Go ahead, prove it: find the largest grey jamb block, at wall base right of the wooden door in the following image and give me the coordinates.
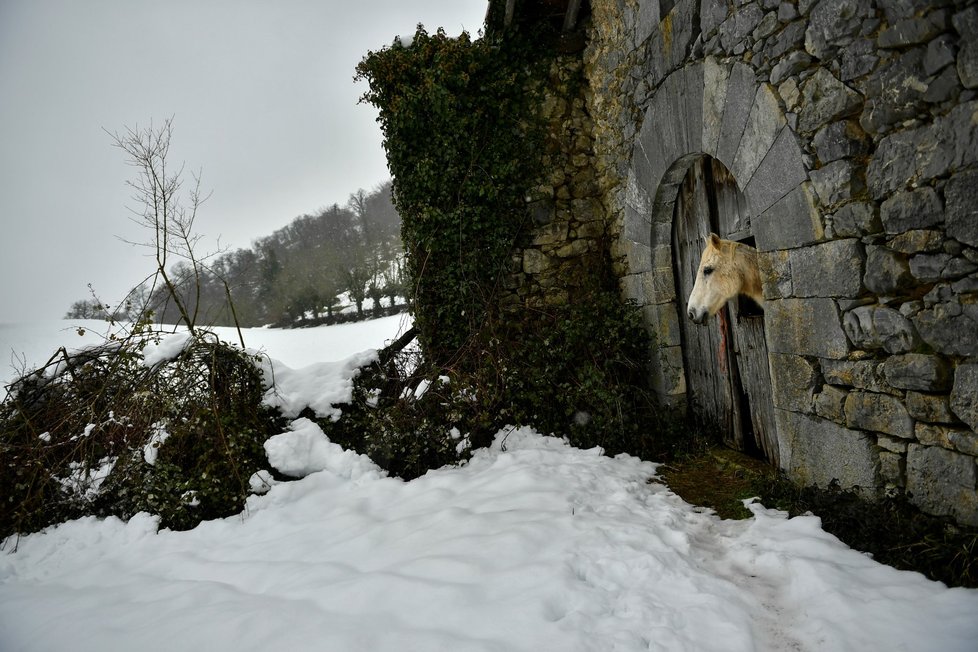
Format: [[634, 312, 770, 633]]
[[776, 410, 879, 496]]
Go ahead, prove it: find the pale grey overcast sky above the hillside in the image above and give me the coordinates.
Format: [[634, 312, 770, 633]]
[[0, 0, 487, 322]]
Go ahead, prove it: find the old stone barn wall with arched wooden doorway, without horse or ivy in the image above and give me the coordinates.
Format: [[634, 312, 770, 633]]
[[503, 0, 978, 525]]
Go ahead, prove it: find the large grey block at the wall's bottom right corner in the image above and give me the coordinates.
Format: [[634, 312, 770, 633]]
[[907, 444, 978, 526]]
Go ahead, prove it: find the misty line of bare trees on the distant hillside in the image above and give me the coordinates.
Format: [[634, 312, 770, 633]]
[[65, 181, 407, 327]]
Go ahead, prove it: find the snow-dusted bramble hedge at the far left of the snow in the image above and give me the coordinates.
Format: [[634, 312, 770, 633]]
[[0, 324, 282, 539]]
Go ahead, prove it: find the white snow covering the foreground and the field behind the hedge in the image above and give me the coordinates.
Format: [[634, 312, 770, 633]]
[[0, 318, 978, 652]]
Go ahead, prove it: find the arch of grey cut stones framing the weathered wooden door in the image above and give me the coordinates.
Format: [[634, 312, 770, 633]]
[[621, 58, 824, 464]]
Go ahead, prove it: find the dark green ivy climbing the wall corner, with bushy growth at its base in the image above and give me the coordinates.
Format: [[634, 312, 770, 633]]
[[348, 21, 661, 468]]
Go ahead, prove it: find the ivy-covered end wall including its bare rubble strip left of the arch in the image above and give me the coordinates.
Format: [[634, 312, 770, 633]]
[[358, 11, 668, 454]]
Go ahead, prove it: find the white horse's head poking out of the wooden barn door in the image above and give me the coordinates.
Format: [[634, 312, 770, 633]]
[[686, 233, 764, 324]]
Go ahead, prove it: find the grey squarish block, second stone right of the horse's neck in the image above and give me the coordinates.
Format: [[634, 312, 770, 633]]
[[789, 239, 866, 297]]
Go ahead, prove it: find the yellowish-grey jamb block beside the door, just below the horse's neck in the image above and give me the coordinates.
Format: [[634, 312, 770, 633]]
[[764, 298, 849, 359]]
